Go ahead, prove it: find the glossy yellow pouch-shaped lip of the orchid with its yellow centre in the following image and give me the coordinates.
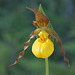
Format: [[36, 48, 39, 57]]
[[32, 30, 54, 58]]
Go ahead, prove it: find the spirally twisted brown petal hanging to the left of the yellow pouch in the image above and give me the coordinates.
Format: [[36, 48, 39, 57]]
[[9, 28, 42, 67]]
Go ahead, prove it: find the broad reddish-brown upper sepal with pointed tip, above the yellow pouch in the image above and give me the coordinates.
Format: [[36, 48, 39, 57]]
[[27, 7, 49, 27]]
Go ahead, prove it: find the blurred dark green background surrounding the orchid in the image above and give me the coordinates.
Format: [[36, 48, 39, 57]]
[[0, 0, 75, 75]]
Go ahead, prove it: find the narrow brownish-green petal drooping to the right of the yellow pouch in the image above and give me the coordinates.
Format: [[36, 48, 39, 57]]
[[45, 28, 71, 70]]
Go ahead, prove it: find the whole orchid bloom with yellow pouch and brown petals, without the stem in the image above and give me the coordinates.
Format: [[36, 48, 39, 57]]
[[9, 8, 70, 69]]
